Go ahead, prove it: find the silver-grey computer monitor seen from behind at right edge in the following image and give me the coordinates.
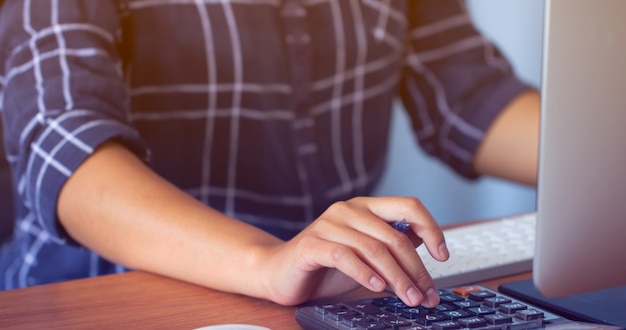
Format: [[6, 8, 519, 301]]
[[533, 0, 626, 297]]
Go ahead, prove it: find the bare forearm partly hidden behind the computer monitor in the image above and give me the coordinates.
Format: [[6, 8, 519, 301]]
[[474, 92, 540, 186]]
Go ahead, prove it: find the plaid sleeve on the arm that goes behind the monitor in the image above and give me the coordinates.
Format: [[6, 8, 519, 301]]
[[400, 0, 532, 178]]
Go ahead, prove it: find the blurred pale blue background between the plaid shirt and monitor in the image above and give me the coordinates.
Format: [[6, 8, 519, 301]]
[[375, 0, 544, 225]]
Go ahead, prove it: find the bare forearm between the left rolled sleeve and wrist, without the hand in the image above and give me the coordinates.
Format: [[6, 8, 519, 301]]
[[58, 143, 279, 296]]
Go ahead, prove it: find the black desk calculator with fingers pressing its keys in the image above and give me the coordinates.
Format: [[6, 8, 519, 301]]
[[296, 286, 568, 330]]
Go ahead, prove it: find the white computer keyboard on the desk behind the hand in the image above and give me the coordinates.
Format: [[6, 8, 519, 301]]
[[417, 213, 536, 288]]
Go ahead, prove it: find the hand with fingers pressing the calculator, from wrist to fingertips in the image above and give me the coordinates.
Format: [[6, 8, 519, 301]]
[[261, 197, 449, 307]]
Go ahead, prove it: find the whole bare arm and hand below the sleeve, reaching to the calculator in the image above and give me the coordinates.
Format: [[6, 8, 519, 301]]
[[58, 143, 448, 306]]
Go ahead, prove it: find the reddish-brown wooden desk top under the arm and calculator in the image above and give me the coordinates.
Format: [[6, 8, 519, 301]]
[[0, 272, 531, 330]]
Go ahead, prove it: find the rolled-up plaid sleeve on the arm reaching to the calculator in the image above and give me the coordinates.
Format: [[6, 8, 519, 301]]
[[0, 0, 148, 241]]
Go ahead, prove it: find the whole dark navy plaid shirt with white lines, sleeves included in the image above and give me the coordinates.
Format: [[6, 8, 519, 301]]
[[0, 0, 528, 288]]
